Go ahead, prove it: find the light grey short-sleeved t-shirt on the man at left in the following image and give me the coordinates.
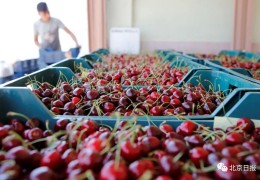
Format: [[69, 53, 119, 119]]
[[34, 17, 65, 51]]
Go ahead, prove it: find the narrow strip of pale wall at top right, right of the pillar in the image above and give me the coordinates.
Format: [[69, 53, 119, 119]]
[[253, 0, 260, 43]]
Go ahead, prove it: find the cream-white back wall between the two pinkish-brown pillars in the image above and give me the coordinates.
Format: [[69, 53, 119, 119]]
[[107, 0, 234, 52]]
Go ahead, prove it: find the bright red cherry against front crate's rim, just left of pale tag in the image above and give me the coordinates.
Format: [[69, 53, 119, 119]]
[[176, 121, 198, 136]]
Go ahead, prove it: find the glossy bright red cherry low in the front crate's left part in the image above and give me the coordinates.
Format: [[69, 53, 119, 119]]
[[41, 150, 63, 170]]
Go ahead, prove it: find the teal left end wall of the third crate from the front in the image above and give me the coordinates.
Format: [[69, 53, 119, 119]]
[[50, 59, 94, 73]]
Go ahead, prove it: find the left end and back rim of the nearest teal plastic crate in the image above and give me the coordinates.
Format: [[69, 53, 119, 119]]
[[0, 87, 213, 129]]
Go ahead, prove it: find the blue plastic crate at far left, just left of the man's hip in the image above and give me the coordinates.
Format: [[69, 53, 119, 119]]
[[13, 59, 39, 73]]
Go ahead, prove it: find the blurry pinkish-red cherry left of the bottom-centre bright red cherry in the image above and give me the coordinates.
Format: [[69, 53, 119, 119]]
[[78, 149, 102, 169]]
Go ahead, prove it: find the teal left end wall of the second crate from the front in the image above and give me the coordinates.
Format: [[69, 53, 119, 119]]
[[1, 67, 77, 87]]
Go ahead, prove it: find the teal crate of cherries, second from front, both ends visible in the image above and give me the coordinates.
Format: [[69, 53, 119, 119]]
[[2, 68, 260, 121]]
